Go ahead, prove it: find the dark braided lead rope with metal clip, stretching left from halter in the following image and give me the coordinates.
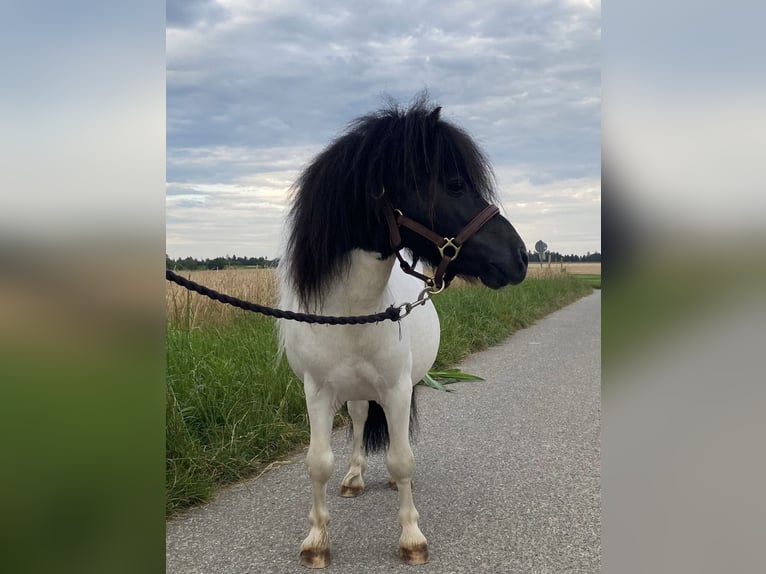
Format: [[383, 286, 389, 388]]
[[165, 269, 408, 325]]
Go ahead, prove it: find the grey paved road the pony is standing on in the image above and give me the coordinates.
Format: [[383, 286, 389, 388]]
[[167, 291, 601, 574]]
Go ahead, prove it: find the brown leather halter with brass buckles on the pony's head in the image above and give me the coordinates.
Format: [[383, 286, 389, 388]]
[[383, 201, 500, 293]]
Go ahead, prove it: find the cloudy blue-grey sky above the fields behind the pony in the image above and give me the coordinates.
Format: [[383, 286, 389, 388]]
[[166, 0, 601, 258]]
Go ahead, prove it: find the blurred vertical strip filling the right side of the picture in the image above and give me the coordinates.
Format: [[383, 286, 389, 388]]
[[602, 1, 766, 573]]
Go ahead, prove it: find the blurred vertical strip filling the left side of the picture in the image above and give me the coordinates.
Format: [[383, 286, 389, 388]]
[[0, 0, 165, 573]]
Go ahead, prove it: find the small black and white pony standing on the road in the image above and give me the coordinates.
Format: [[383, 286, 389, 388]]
[[279, 96, 527, 568]]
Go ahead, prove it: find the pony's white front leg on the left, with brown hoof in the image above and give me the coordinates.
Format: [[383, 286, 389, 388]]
[[300, 390, 335, 568]]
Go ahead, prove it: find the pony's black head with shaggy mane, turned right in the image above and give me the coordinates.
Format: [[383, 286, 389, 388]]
[[286, 95, 527, 303]]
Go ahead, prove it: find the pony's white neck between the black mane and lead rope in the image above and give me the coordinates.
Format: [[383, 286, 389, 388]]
[[325, 249, 396, 315]]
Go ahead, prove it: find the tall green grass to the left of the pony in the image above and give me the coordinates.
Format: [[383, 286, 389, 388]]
[[166, 313, 309, 512]]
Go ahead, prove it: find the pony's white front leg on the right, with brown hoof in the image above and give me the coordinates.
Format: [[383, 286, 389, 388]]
[[383, 390, 428, 564]]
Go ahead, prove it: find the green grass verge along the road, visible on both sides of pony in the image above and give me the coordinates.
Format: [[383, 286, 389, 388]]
[[166, 275, 591, 514]]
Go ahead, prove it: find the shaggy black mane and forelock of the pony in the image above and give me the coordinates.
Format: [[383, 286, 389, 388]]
[[285, 94, 495, 306]]
